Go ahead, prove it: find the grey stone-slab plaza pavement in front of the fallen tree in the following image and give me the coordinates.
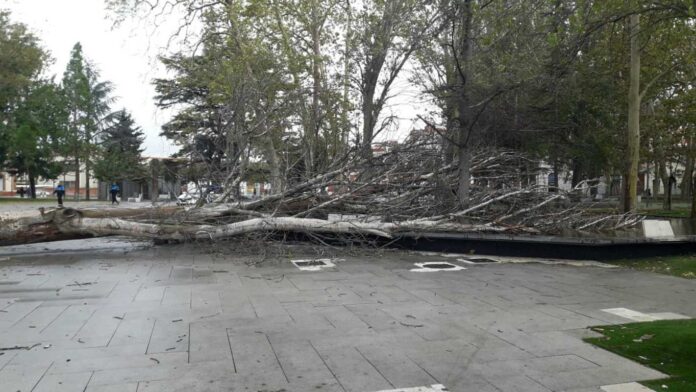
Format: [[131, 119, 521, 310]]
[[0, 245, 696, 392]]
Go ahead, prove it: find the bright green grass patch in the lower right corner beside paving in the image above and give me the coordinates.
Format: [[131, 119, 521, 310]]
[[585, 320, 696, 392]]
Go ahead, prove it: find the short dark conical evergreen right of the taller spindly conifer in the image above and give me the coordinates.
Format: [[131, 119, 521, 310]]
[[94, 109, 146, 182]]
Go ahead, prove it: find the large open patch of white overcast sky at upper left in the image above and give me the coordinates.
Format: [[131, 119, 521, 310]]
[[0, 0, 176, 156]]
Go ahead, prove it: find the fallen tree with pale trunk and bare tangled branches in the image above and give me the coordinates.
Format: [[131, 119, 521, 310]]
[[0, 145, 641, 244]]
